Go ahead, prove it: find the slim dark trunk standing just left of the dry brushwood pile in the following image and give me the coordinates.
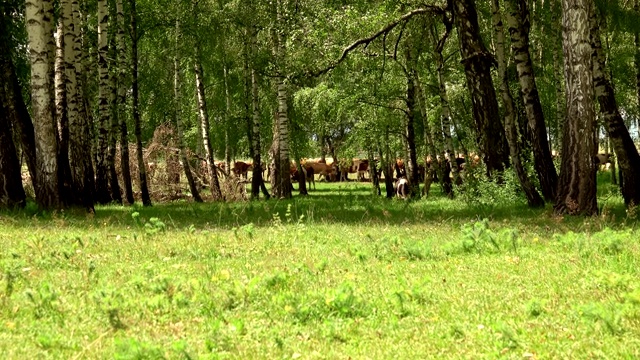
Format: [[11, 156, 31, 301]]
[[130, 0, 151, 206]]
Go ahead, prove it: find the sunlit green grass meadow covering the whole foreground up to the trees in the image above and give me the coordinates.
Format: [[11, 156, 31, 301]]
[[0, 178, 640, 359]]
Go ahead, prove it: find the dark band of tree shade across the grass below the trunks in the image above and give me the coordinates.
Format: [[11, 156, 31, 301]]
[[0, 179, 636, 234]]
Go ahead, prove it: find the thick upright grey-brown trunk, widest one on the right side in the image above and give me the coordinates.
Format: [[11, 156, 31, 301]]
[[554, 0, 598, 215]]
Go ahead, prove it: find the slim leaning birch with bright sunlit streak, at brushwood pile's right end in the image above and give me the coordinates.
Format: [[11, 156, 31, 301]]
[[194, 44, 222, 201]]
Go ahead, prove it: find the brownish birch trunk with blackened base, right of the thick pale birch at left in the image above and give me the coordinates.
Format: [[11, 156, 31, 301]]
[[65, 0, 95, 212]]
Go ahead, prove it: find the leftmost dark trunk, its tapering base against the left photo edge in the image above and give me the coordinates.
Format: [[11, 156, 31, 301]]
[[0, 101, 27, 209]]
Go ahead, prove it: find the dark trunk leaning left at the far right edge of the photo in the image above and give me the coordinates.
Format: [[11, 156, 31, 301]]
[[591, 11, 640, 207]]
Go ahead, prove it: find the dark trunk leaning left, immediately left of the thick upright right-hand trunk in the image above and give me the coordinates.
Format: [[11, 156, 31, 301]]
[[506, 0, 558, 201]]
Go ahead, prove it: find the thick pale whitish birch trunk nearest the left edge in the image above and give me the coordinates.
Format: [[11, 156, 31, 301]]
[[25, 0, 62, 209]]
